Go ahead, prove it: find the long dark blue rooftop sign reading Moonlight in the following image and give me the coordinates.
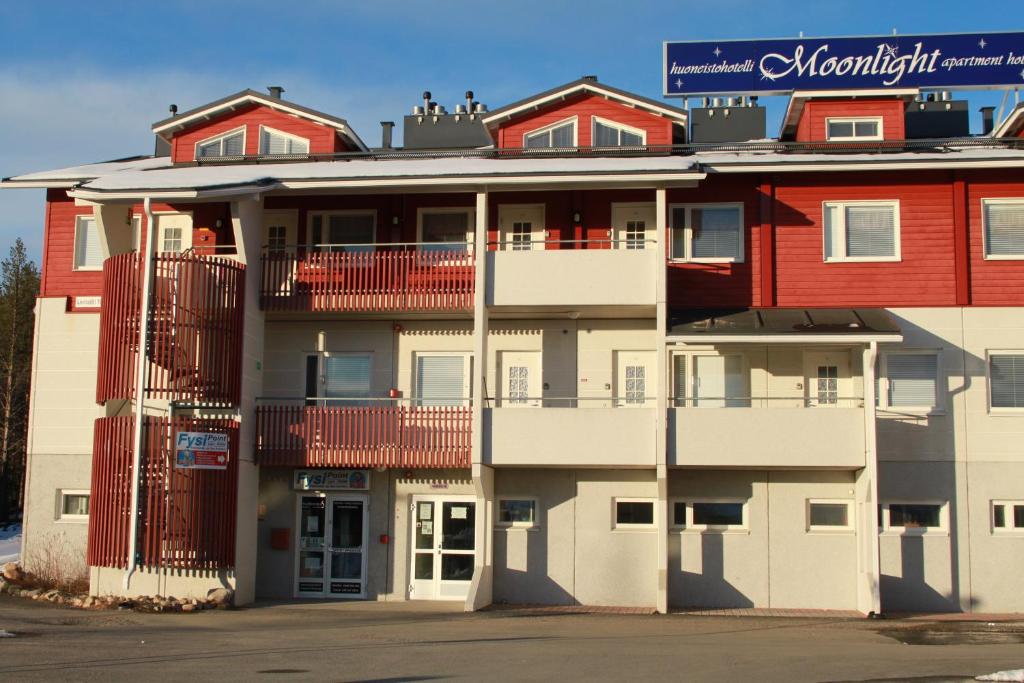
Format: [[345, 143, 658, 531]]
[[664, 33, 1024, 96]]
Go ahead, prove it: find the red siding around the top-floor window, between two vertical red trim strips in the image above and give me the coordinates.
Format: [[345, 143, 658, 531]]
[[774, 172, 956, 306]]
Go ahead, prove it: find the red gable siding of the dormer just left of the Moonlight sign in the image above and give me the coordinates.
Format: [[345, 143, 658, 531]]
[[498, 94, 672, 148]]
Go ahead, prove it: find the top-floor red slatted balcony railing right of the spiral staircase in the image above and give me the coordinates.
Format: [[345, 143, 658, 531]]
[[260, 249, 475, 311]]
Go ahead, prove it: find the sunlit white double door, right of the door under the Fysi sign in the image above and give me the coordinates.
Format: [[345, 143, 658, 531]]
[[409, 496, 476, 600]]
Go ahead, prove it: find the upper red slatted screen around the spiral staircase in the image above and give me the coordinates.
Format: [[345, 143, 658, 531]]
[[96, 254, 245, 404]]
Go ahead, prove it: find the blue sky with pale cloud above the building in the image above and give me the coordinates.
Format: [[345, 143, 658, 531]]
[[0, 0, 1024, 259]]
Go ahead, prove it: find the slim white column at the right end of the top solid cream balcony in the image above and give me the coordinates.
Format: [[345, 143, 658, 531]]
[[654, 187, 670, 614]]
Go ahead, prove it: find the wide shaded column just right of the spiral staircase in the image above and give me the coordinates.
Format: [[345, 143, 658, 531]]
[[231, 198, 264, 604]]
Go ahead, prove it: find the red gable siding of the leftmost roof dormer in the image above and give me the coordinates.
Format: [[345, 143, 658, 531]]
[[171, 104, 345, 163]]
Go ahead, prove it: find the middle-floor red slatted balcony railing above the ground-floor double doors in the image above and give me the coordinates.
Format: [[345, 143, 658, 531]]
[[256, 404, 472, 467]]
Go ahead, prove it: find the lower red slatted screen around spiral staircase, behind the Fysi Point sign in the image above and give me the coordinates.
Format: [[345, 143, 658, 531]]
[[88, 416, 239, 569]]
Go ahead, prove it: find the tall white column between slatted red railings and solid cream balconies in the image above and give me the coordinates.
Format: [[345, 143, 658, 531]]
[[466, 188, 495, 611]]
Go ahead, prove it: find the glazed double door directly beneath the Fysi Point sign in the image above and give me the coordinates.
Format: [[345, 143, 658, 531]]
[[295, 493, 370, 598]]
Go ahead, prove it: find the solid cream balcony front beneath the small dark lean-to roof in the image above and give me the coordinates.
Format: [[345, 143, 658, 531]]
[[669, 398, 865, 469]]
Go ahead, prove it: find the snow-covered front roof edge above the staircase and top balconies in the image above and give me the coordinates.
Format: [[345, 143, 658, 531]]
[[70, 156, 701, 193]]
